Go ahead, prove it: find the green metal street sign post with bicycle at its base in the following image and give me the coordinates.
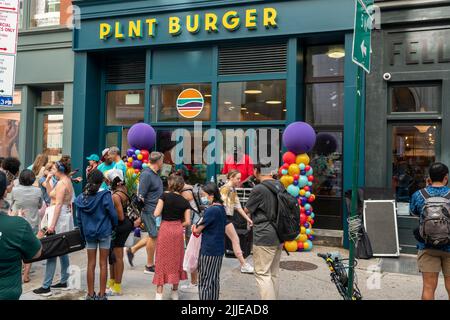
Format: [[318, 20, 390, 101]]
[[347, 66, 364, 300]]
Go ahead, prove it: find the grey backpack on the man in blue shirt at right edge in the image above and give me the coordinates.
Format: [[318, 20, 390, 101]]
[[419, 189, 450, 247]]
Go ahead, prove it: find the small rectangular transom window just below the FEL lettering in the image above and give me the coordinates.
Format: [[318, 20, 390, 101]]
[[390, 84, 442, 113]]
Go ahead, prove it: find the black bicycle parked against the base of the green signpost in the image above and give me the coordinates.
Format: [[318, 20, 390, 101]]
[[317, 253, 362, 300]]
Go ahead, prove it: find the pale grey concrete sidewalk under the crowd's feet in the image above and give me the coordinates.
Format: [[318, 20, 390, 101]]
[[21, 246, 448, 300]]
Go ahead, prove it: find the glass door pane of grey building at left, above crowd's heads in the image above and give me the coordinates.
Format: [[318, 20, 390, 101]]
[[36, 110, 64, 161]]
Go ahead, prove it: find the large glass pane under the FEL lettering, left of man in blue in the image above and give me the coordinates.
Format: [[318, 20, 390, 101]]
[[391, 123, 440, 202]]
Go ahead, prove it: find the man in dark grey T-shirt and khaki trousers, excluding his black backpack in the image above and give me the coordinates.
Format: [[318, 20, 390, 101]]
[[245, 164, 284, 300]]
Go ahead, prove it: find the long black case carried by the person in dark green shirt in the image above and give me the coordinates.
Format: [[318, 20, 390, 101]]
[[23, 228, 86, 263]]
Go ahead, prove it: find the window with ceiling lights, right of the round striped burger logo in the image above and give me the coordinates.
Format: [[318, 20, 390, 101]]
[[218, 80, 286, 121]]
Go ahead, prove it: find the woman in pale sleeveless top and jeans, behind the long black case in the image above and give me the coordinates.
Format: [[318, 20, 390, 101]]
[[33, 158, 74, 297]]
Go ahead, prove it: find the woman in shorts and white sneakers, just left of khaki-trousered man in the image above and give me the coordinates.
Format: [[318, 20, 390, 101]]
[[220, 170, 254, 273]]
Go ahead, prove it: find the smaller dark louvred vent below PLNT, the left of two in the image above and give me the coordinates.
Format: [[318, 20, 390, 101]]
[[106, 54, 145, 84]]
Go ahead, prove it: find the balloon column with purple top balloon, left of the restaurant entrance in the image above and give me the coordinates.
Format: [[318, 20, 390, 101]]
[[126, 123, 156, 194]]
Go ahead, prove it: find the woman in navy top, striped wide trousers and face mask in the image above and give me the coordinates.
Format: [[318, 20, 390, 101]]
[[192, 182, 227, 300]]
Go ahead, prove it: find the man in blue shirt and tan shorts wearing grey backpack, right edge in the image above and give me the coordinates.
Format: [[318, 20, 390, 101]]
[[410, 163, 450, 300]]
